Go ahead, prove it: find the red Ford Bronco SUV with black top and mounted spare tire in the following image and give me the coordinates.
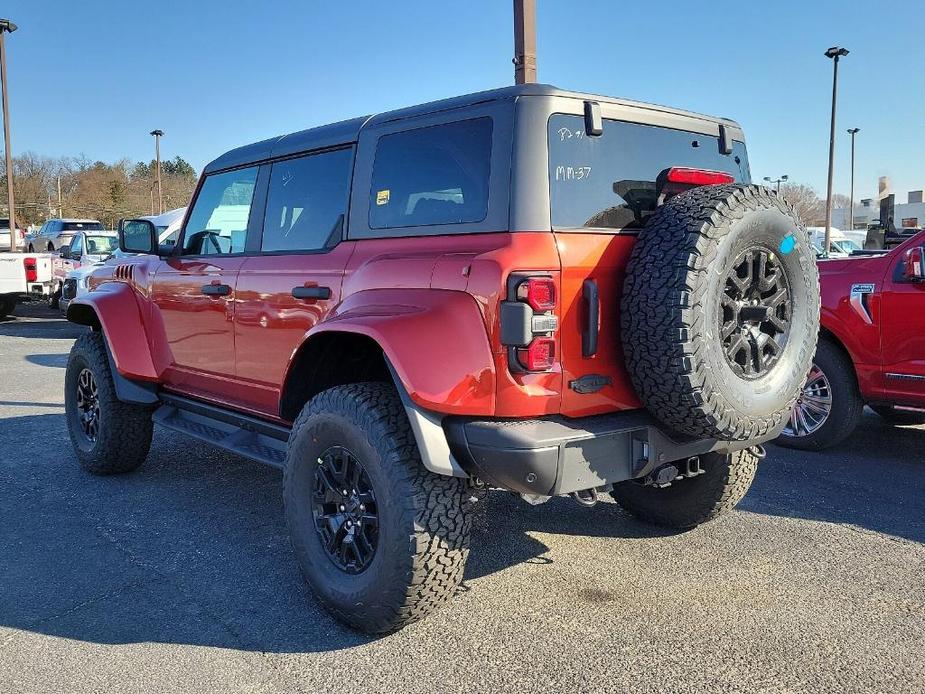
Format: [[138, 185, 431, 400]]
[[65, 84, 819, 632]]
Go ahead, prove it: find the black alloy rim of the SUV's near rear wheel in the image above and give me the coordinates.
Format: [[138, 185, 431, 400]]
[[312, 446, 379, 574]]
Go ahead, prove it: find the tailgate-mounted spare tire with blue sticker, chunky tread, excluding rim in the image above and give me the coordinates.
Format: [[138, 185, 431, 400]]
[[621, 184, 819, 440]]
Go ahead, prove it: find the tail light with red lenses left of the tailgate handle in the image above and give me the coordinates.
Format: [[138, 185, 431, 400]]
[[500, 274, 559, 373]]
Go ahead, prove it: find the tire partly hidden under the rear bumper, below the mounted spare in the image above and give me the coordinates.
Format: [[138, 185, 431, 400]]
[[610, 449, 758, 530]]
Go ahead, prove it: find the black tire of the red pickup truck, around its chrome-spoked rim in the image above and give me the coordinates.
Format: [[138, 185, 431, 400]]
[[775, 339, 864, 451]]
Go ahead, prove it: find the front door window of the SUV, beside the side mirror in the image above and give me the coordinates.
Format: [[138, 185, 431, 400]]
[[183, 166, 257, 255]]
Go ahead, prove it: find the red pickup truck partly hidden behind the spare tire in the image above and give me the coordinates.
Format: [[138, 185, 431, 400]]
[[778, 231, 925, 450]]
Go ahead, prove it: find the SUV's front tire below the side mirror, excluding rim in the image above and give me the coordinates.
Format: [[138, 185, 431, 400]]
[[64, 331, 154, 475]]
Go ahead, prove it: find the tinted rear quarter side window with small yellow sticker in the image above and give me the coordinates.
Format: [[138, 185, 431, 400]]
[[369, 117, 491, 229]]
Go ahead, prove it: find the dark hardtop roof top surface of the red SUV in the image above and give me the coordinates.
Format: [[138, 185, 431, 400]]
[[204, 84, 738, 173]]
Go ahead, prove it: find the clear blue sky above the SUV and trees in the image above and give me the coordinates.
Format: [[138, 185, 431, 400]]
[[0, 0, 925, 201]]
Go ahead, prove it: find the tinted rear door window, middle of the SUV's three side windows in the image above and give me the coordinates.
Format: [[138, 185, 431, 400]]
[[261, 149, 353, 251]]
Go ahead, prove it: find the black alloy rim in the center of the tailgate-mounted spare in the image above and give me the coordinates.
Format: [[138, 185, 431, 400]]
[[719, 247, 791, 380]]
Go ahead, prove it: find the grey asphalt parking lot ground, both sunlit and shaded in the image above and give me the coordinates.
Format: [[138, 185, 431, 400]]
[[0, 306, 925, 693]]
